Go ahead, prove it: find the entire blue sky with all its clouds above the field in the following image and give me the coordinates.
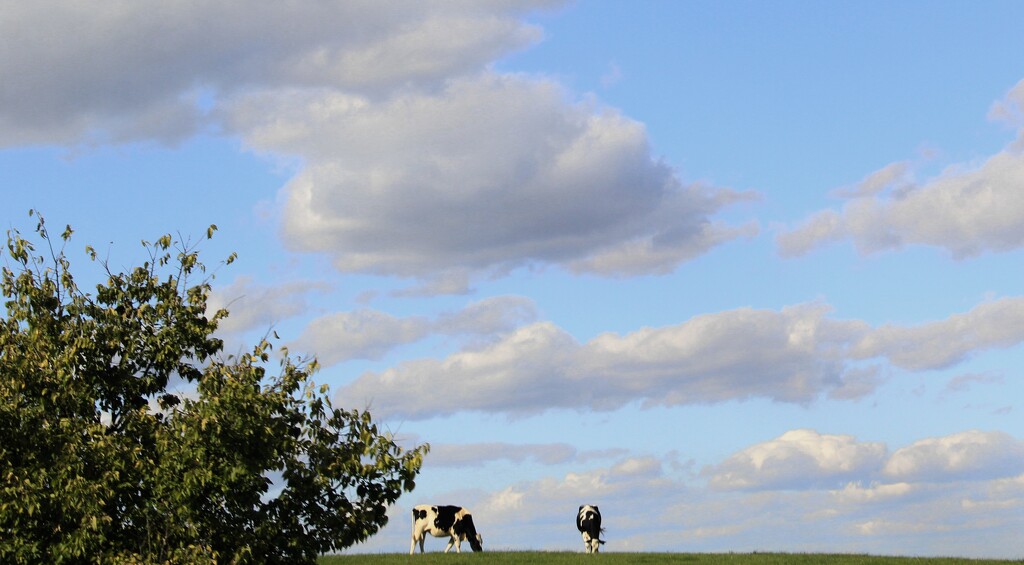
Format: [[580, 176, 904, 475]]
[[0, 0, 1024, 559]]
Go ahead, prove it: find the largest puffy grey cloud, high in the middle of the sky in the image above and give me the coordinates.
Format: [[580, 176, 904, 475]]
[[228, 73, 757, 276]]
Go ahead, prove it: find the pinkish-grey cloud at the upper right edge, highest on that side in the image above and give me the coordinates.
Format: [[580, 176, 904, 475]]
[[776, 84, 1024, 259]]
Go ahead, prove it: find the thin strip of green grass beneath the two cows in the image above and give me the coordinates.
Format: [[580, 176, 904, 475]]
[[319, 552, 1021, 565]]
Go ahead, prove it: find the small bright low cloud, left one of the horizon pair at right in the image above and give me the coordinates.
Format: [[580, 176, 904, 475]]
[[703, 430, 886, 490]]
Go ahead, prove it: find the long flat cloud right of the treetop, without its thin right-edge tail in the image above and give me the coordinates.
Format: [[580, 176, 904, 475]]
[[338, 304, 861, 419]]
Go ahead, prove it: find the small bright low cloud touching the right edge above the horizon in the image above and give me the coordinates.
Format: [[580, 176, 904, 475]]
[[883, 430, 1024, 481]]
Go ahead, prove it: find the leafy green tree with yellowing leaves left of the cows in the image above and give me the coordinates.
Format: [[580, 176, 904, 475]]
[[0, 212, 428, 563]]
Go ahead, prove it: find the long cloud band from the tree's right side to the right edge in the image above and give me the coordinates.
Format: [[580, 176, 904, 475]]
[[337, 297, 1024, 419]]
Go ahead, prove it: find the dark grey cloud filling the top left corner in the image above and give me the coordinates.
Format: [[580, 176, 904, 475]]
[[0, 0, 557, 146]]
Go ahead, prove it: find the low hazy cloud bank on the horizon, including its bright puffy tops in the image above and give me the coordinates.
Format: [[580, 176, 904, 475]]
[[368, 429, 1024, 559]]
